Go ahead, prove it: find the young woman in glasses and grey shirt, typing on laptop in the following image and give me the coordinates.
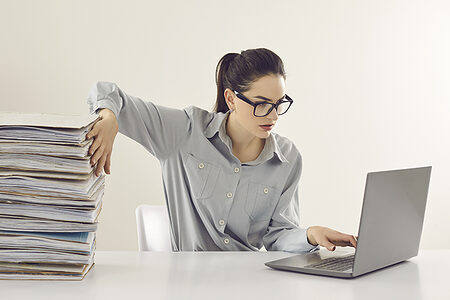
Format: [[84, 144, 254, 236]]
[[87, 48, 356, 252]]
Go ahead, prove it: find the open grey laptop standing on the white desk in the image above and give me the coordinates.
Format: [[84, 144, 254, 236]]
[[265, 166, 431, 278]]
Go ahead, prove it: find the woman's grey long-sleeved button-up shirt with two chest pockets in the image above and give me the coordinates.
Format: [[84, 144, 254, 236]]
[[87, 82, 319, 252]]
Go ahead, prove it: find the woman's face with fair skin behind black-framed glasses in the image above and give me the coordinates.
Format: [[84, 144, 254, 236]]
[[225, 74, 285, 139]]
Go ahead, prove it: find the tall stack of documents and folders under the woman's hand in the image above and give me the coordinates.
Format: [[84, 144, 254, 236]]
[[0, 112, 105, 280]]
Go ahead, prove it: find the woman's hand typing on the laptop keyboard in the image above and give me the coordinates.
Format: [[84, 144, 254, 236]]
[[306, 226, 358, 251]]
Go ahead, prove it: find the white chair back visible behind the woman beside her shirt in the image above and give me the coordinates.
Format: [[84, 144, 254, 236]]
[[136, 204, 172, 252]]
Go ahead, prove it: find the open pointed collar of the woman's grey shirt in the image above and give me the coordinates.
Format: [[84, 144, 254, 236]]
[[204, 111, 289, 163]]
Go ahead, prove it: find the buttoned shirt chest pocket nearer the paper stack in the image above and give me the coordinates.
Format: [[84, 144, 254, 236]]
[[186, 153, 220, 199]]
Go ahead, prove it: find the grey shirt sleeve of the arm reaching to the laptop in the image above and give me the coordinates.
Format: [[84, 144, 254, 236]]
[[263, 153, 320, 253]]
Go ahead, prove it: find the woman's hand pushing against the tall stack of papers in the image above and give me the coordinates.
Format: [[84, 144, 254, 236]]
[[86, 108, 119, 176]]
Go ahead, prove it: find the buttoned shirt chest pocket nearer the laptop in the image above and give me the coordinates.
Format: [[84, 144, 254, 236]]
[[245, 181, 281, 222]]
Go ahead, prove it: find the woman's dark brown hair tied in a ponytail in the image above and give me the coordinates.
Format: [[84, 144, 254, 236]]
[[214, 48, 286, 113]]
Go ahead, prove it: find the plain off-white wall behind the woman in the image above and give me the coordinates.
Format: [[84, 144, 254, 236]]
[[0, 0, 450, 250]]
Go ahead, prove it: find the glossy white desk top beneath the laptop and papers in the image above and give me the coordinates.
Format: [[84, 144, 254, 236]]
[[0, 249, 450, 300]]
